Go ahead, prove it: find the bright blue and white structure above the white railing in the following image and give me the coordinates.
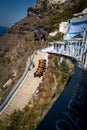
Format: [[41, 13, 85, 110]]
[[64, 15, 87, 40]]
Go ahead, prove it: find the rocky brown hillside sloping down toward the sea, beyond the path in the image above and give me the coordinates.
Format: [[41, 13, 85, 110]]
[[0, 0, 87, 102]]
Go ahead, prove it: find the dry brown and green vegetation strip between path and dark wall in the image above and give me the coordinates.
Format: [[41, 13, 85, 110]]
[[0, 55, 75, 130]]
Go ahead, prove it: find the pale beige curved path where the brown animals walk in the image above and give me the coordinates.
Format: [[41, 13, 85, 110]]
[[0, 52, 46, 119]]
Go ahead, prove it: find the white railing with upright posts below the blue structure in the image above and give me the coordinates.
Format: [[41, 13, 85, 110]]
[[47, 40, 87, 68]]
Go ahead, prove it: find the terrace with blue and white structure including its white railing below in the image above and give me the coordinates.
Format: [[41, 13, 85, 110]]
[[41, 16, 87, 68]]
